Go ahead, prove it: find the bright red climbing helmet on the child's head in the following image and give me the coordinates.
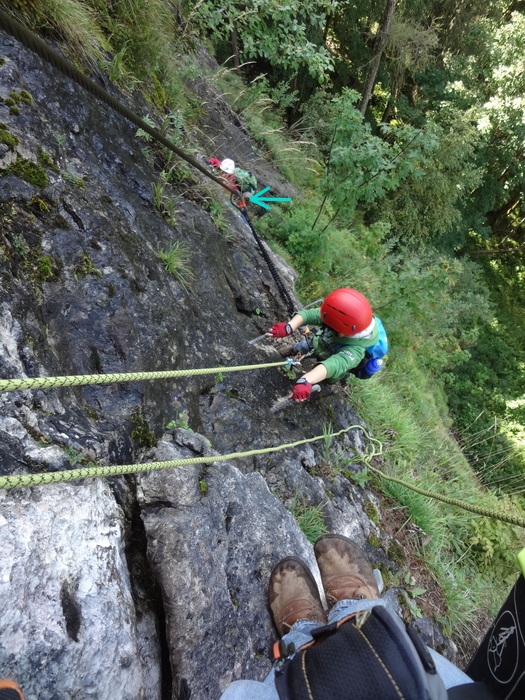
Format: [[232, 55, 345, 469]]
[[321, 287, 373, 335]]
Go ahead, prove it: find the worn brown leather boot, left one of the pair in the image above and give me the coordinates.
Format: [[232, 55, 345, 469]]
[[268, 557, 326, 637]]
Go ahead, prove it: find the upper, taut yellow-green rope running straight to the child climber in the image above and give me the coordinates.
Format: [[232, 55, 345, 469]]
[[0, 361, 286, 391]]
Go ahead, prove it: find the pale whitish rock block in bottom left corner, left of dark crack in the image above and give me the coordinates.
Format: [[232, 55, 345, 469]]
[[0, 479, 160, 700]]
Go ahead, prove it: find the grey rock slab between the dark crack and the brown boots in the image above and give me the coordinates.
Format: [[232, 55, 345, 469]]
[[133, 430, 374, 698]]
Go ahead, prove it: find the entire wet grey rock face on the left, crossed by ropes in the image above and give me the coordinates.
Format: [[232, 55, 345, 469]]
[[0, 28, 450, 700]]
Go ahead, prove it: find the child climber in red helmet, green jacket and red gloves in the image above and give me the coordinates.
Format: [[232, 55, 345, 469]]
[[268, 287, 380, 401]]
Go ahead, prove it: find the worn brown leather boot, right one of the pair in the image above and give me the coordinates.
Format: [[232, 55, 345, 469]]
[[314, 535, 379, 608]]
